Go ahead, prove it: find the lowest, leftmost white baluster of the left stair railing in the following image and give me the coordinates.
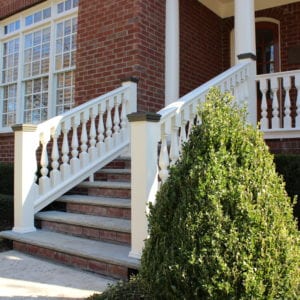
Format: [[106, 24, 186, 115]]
[[39, 133, 50, 195]]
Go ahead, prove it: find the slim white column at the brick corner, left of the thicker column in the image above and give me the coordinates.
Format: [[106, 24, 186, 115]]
[[165, 0, 179, 105]]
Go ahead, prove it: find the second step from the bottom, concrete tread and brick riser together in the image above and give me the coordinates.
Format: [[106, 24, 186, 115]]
[[35, 211, 131, 245]]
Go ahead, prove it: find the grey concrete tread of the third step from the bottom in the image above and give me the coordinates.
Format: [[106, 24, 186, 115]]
[[56, 195, 131, 208]]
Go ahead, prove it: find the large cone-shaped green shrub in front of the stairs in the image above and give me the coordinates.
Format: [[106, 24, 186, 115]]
[[141, 90, 300, 299]]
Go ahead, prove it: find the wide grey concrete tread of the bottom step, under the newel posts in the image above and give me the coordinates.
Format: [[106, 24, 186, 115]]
[[0, 230, 140, 269]]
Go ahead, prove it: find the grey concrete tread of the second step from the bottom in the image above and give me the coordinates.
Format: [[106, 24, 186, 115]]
[[35, 211, 131, 233]]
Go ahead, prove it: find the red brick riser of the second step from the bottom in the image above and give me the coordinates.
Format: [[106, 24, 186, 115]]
[[37, 220, 131, 245]]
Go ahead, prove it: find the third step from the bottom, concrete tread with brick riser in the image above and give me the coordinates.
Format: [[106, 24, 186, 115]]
[[56, 195, 131, 219]]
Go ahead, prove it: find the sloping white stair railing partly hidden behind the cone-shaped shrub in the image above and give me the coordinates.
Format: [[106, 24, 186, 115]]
[[158, 62, 250, 182]]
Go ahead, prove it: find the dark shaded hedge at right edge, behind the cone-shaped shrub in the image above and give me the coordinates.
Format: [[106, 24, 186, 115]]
[[274, 154, 300, 227]]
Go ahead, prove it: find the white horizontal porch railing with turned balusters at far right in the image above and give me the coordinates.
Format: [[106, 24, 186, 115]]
[[256, 70, 300, 139]]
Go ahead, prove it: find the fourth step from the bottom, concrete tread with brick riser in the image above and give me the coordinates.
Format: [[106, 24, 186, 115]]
[[72, 181, 131, 199]]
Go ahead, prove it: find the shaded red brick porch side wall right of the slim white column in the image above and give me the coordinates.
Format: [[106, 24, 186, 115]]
[[180, 0, 223, 95]]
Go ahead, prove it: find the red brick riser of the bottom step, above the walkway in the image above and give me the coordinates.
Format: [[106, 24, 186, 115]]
[[13, 241, 128, 280]]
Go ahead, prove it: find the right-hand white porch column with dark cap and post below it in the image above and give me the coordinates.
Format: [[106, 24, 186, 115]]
[[234, 0, 257, 125]]
